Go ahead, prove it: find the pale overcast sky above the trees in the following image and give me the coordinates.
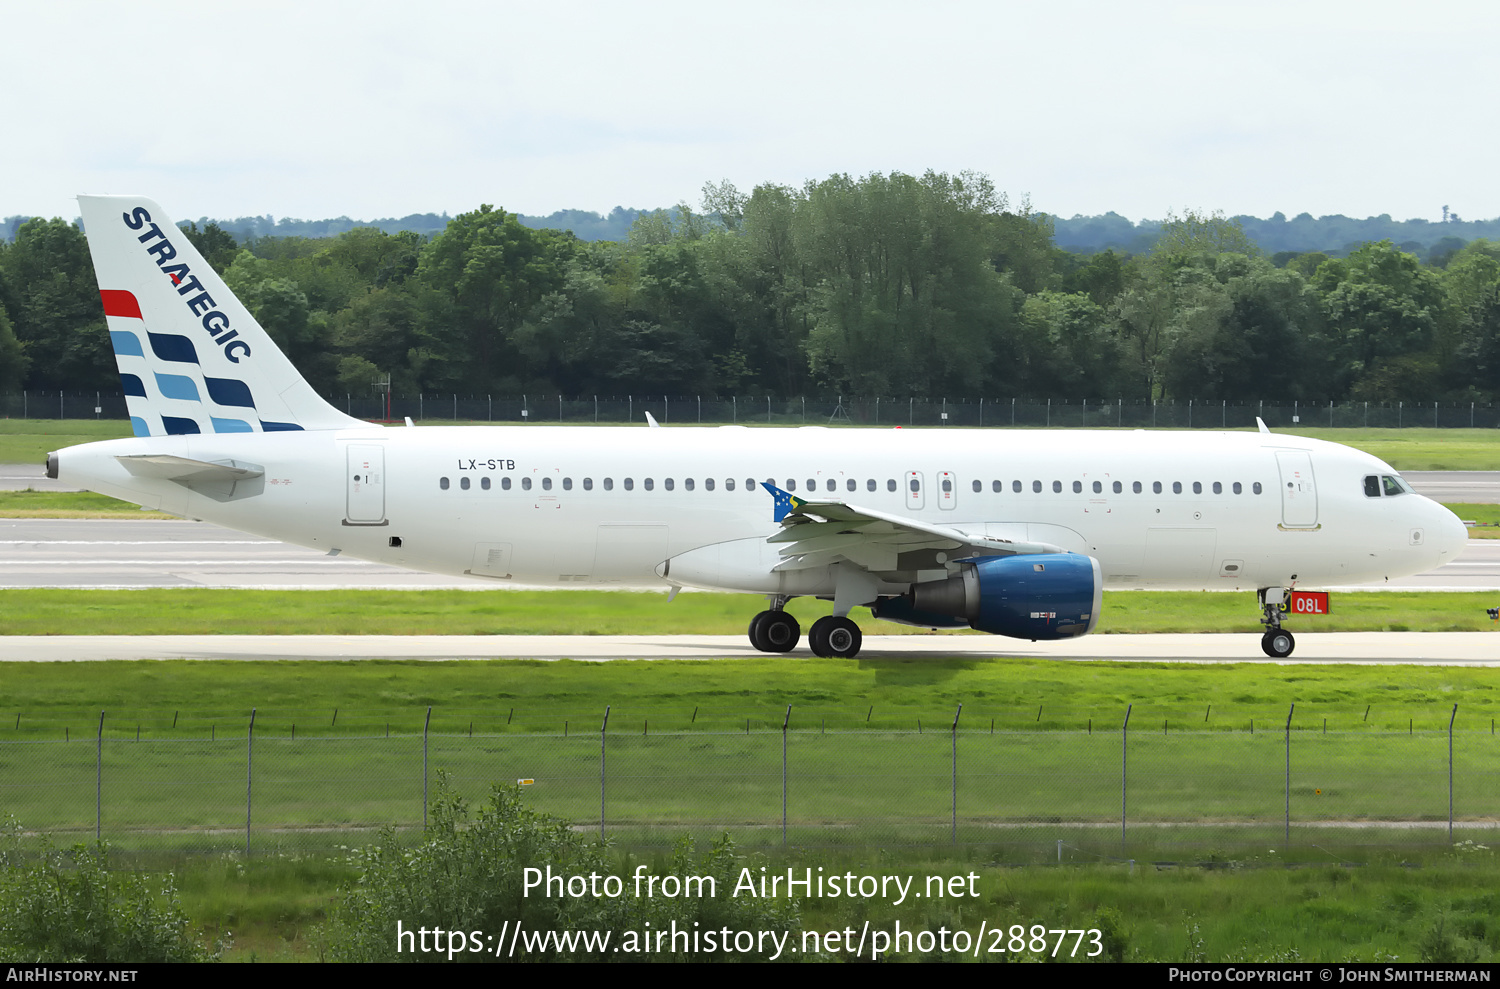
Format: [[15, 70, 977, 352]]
[[0, 0, 1500, 221]]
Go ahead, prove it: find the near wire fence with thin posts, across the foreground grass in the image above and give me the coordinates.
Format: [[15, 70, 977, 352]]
[[0, 708, 1500, 861]]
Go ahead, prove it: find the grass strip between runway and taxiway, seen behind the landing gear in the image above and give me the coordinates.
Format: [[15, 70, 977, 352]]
[[0, 587, 1500, 635]]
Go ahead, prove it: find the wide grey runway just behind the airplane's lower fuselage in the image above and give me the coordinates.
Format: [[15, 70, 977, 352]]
[[0, 519, 1500, 591]]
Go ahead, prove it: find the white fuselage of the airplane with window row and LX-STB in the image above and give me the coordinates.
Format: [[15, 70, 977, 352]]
[[59, 426, 1466, 594]]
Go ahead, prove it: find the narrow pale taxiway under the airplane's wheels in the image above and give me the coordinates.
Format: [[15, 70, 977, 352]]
[[0, 632, 1500, 668]]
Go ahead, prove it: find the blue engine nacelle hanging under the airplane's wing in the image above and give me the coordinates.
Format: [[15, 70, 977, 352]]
[[908, 552, 1104, 639]]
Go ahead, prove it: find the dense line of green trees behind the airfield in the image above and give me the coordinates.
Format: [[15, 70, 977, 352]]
[[0, 173, 1500, 402]]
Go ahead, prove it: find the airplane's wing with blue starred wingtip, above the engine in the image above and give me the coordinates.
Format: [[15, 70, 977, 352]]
[[762, 482, 1067, 572]]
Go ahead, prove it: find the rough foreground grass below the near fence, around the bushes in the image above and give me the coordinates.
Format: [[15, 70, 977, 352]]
[[93, 810, 1500, 963]]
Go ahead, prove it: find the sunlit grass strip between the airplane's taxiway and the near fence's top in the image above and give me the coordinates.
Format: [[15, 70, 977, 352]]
[[0, 657, 1500, 735]]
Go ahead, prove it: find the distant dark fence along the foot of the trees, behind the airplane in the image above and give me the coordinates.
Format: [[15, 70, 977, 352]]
[[11, 392, 1500, 429]]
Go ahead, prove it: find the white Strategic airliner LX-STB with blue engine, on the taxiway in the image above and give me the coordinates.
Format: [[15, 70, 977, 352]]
[[47, 197, 1467, 657]]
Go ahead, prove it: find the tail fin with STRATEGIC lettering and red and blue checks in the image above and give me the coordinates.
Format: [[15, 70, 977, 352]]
[[78, 195, 368, 437]]
